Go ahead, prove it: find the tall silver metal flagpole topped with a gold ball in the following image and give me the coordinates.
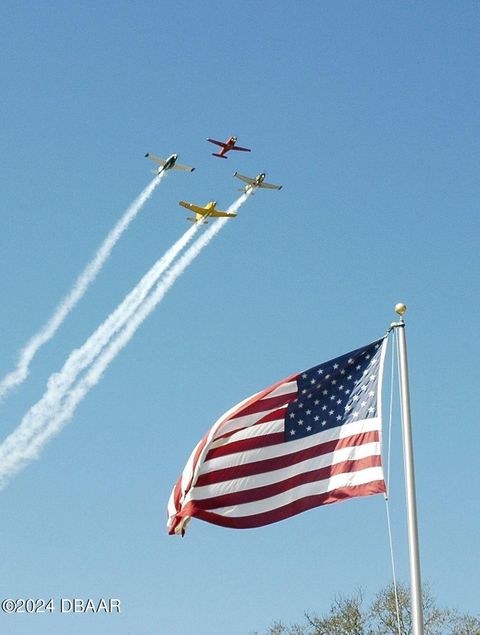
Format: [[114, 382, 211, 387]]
[[392, 304, 423, 635]]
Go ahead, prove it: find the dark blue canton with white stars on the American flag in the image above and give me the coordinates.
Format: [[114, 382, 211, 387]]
[[285, 338, 383, 441]]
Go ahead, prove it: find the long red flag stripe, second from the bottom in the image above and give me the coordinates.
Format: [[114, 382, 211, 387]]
[[189, 455, 382, 509]]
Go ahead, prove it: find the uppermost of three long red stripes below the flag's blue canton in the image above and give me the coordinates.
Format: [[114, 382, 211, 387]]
[[195, 430, 379, 487]]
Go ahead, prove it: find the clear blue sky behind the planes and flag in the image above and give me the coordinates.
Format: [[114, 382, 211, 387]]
[[0, 0, 480, 635]]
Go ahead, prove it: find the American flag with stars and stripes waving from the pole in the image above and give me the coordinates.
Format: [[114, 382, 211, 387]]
[[168, 338, 386, 535]]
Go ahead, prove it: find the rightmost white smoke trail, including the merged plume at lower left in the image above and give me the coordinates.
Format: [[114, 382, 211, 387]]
[[0, 193, 249, 489]]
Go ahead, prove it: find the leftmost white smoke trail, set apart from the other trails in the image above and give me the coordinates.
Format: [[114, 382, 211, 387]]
[[0, 172, 165, 401]]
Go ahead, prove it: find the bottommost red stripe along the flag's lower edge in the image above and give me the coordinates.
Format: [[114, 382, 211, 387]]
[[169, 479, 385, 534]]
